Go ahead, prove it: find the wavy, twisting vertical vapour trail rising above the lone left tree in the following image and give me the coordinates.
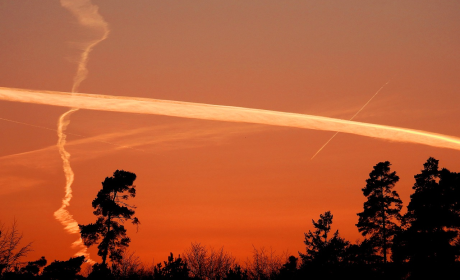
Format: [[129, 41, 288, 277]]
[[54, 0, 109, 263]]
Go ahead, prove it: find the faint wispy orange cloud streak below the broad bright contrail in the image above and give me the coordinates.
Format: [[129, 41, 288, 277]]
[[0, 121, 270, 195]]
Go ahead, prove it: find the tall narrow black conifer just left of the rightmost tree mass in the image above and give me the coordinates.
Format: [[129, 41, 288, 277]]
[[356, 161, 402, 264]]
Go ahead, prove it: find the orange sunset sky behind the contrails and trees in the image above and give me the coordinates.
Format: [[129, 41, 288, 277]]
[[0, 0, 460, 262]]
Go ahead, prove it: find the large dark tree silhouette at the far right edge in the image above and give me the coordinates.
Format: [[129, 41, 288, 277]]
[[393, 157, 460, 278]]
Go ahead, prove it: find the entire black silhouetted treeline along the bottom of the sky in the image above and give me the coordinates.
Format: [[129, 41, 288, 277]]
[[0, 158, 460, 280]]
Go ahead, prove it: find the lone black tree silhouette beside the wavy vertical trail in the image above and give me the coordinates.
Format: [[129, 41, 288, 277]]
[[78, 170, 139, 266]]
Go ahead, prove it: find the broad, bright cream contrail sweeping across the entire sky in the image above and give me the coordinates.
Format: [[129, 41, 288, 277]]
[[0, 87, 460, 151]]
